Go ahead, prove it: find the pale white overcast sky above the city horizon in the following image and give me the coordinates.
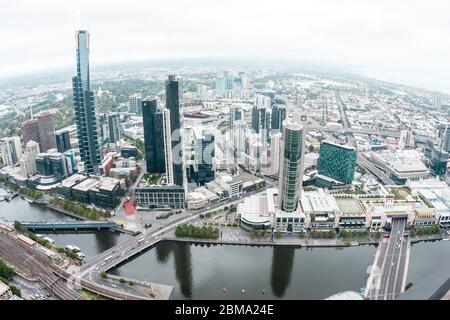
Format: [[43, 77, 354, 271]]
[[0, 0, 450, 93]]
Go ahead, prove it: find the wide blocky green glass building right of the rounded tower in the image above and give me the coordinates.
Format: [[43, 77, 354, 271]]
[[317, 141, 357, 184]]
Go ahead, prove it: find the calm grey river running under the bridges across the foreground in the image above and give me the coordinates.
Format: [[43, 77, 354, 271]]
[[0, 190, 450, 300]]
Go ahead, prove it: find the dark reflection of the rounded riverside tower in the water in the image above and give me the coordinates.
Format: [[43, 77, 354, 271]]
[[270, 247, 295, 298]]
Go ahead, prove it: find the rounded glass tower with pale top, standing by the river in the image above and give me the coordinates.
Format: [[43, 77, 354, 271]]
[[278, 119, 306, 212]]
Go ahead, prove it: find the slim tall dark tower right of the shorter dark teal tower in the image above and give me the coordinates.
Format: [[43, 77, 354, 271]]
[[166, 75, 183, 186]]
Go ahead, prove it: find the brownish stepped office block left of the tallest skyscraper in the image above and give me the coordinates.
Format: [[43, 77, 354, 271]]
[[22, 112, 56, 152]]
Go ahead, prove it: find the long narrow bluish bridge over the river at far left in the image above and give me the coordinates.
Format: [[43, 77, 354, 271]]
[[22, 221, 120, 231]]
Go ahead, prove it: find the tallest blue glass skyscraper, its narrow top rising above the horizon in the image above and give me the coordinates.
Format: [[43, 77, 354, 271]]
[[72, 30, 102, 174]]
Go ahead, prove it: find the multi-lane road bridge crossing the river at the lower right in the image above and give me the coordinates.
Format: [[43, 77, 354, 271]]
[[367, 218, 410, 300]]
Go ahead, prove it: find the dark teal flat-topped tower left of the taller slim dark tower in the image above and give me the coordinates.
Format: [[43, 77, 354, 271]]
[[142, 99, 166, 173]]
